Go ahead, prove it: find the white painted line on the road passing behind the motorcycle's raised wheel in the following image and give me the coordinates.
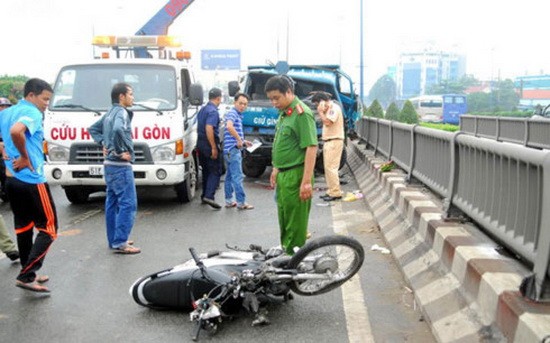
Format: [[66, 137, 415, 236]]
[[331, 201, 374, 343]]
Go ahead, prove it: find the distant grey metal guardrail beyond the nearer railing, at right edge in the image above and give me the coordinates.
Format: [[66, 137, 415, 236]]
[[460, 115, 550, 149]]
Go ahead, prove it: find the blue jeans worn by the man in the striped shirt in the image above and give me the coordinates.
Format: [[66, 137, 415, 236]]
[[223, 147, 245, 206]]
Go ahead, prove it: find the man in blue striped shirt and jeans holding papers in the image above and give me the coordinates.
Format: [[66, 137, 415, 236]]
[[223, 93, 254, 210]]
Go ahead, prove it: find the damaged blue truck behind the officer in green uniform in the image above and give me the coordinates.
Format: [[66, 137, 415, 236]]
[[229, 62, 359, 177]]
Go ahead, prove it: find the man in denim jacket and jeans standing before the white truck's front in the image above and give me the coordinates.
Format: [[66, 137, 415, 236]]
[[88, 83, 141, 254]]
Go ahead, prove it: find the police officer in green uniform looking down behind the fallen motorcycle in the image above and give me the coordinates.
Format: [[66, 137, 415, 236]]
[[265, 75, 317, 255]]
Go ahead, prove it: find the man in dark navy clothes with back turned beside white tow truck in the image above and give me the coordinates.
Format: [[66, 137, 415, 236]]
[[197, 88, 222, 209]]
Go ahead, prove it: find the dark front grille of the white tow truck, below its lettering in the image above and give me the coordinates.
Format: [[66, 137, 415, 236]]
[[69, 143, 153, 164]]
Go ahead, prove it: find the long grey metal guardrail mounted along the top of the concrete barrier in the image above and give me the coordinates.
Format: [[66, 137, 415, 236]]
[[357, 118, 550, 301]]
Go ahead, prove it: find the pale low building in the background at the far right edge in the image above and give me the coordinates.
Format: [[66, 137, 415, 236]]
[[514, 75, 550, 109]]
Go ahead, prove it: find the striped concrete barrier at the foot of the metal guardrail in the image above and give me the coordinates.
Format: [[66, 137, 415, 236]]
[[347, 141, 550, 342]]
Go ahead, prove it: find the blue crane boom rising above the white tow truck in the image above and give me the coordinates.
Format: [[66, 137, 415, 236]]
[[134, 0, 195, 58]]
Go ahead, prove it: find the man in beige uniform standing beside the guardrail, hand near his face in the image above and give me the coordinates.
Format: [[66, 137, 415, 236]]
[[311, 92, 344, 201]]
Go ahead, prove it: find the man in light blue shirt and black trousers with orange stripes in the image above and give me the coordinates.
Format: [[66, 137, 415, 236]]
[[0, 79, 57, 292]]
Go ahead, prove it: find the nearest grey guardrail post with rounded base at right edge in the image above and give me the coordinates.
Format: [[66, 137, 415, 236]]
[[520, 153, 550, 302]]
